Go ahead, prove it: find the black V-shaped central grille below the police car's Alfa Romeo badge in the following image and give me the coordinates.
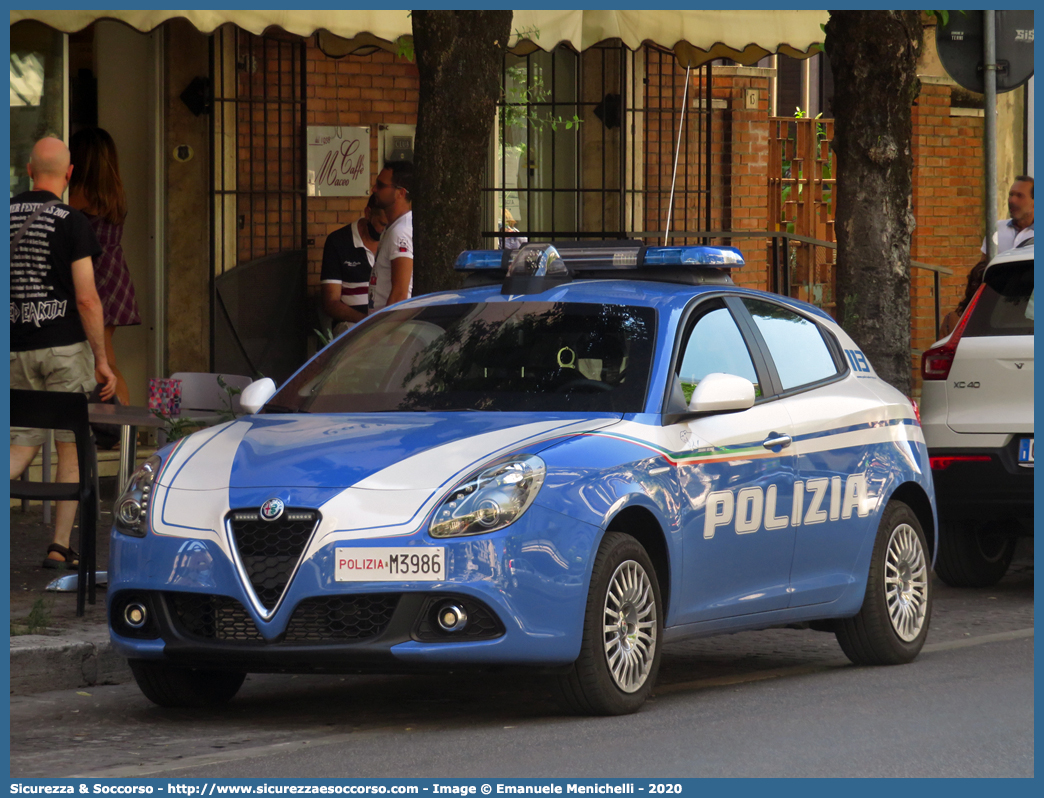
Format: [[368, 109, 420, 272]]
[[229, 508, 318, 610]]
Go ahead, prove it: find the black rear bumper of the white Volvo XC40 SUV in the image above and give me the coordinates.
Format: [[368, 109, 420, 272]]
[[928, 436, 1034, 521]]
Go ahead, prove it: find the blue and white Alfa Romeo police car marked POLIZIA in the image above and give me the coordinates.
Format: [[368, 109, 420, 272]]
[[109, 241, 936, 714]]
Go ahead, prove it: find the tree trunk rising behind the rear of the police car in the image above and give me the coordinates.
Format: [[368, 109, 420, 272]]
[[825, 10, 924, 395]]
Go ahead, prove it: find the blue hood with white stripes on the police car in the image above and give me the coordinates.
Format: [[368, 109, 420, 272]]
[[159, 412, 620, 491]]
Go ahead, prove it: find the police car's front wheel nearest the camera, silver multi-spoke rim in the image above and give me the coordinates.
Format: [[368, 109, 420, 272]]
[[557, 532, 663, 714]]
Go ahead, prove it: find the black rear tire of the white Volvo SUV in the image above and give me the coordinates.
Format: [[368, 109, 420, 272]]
[[935, 521, 1015, 587]]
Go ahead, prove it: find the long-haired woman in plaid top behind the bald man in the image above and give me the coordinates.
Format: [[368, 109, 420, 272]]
[[69, 127, 141, 404]]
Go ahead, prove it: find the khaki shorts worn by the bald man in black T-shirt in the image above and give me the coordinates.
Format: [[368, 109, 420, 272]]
[[10, 341, 96, 446]]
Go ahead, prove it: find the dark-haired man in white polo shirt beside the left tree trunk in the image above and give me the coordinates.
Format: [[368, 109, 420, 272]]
[[370, 161, 413, 313]]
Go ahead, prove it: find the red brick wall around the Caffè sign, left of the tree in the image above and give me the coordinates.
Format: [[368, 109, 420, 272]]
[[305, 40, 418, 292]]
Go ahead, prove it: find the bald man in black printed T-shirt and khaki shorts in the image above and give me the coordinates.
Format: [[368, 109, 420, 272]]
[[10, 138, 116, 568]]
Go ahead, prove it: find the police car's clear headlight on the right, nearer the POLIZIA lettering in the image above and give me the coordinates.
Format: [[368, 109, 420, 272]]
[[430, 454, 547, 538]]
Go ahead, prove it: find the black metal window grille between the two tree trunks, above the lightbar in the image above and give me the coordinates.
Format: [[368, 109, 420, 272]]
[[483, 43, 711, 248]]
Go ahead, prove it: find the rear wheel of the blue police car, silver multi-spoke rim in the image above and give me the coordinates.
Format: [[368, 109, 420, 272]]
[[834, 501, 932, 665]]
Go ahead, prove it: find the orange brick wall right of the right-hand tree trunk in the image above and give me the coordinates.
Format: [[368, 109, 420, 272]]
[[910, 78, 984, 396]]
